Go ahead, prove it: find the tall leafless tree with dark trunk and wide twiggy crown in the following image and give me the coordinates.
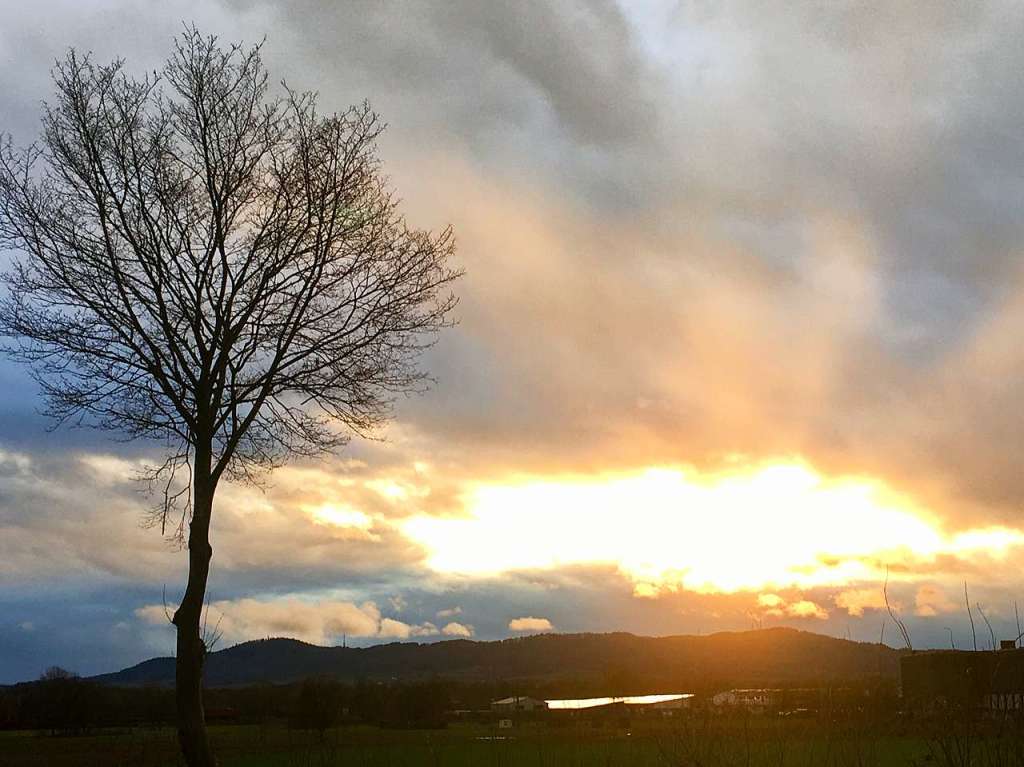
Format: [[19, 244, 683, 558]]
[[0, 29, 459, 765]]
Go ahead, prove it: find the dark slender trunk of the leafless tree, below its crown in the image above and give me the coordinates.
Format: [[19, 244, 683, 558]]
[[172, 442, 216, 767]]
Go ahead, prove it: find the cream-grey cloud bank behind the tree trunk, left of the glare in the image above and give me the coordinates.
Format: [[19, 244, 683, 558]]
[[0, 445, 445, 595]]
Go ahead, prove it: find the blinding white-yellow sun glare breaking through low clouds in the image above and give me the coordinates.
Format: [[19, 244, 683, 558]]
[[403, 463, 1024, 594]]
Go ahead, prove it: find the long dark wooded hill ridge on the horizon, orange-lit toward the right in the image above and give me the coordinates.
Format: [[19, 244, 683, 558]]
[[93, 628, 902, 694]]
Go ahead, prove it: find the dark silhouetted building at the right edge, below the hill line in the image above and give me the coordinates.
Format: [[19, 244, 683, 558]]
[[900, 642, 1024, 713]]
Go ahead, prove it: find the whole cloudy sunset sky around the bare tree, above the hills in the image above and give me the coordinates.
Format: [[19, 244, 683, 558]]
[[0, 0, 1024, 683]]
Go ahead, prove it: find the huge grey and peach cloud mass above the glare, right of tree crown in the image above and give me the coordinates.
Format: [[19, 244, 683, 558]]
[[6, 0, 1024, 528]]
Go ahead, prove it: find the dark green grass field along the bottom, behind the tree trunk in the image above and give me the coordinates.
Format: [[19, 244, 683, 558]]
[[0, 724, 970, 767]]
